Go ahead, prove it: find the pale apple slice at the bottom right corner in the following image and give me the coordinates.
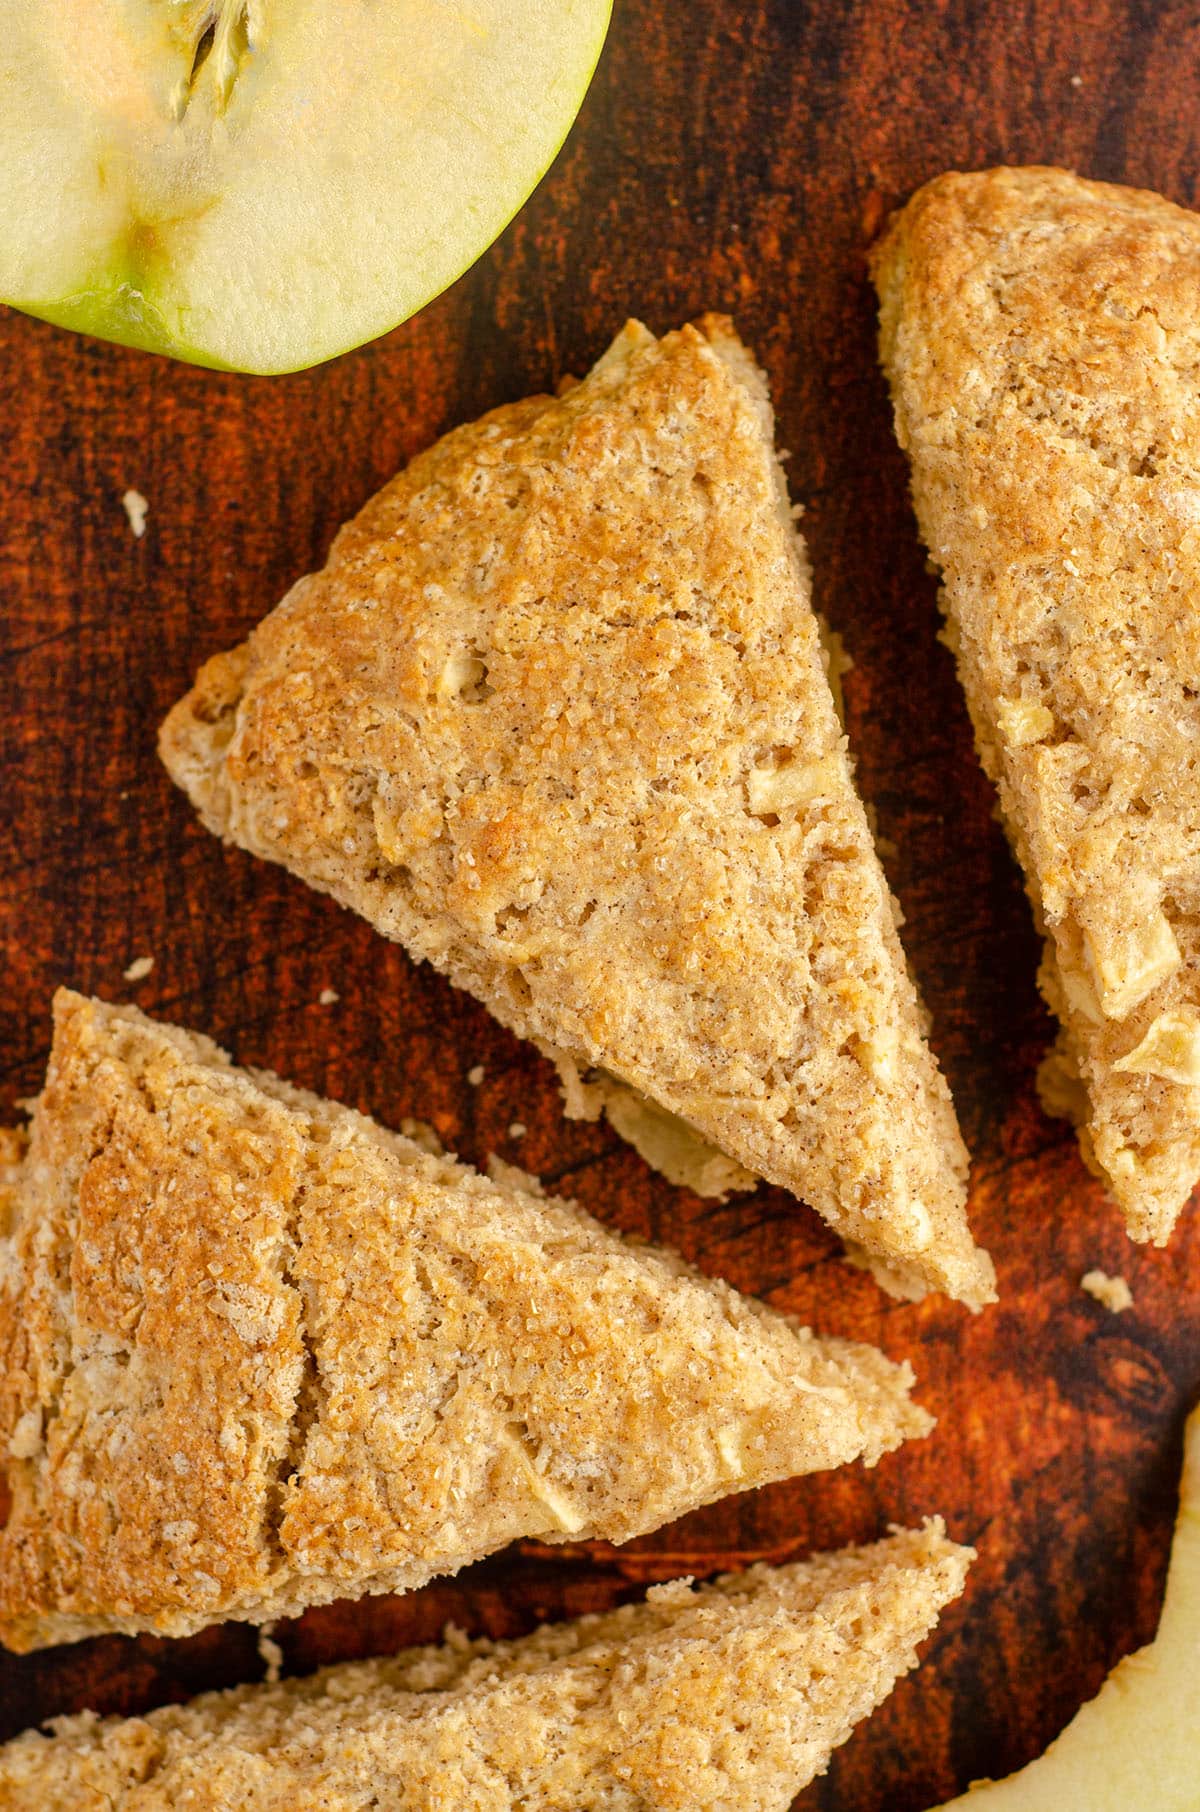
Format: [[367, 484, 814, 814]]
[[939, 1410, 1200, 1812]]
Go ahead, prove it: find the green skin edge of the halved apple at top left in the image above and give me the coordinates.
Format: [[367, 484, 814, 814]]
[[0, 0, 613, 377]]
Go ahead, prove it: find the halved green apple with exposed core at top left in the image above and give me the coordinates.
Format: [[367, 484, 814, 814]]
[[0, 0, 611, 371]]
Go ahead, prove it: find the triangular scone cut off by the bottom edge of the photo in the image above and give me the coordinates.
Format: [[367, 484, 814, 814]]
[[0, 1524, 972, 1812]]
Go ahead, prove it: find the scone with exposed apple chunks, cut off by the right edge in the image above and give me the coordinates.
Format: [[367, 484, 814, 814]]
[[876, 169, 1200, 1245]]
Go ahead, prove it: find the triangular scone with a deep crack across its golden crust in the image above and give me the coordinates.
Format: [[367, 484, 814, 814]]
[[0, 993, 932, 1649]]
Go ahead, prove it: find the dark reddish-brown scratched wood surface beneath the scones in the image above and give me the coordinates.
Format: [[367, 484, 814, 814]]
[[0, 0, 1200, 1812]]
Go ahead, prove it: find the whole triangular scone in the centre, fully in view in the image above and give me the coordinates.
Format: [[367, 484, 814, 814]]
[[161, 319, 992, 1303]]
